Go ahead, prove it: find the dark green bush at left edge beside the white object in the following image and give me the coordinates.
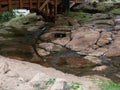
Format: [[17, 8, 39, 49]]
[[0, 11, 16, 22]]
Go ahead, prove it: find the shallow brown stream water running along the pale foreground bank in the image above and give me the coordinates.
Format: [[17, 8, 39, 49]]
[[0, 23, 120, 82]]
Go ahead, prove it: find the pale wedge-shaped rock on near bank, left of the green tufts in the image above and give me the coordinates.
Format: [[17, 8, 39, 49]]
[[28, 73, 49, 86]]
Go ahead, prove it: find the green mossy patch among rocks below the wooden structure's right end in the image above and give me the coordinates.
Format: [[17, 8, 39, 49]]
[[69, 11, 92, 21]]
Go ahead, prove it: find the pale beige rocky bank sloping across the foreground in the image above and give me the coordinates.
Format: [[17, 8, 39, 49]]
[[0, 56, 108, 90]]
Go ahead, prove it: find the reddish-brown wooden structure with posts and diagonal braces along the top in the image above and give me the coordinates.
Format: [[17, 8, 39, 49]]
[[0, 0, 81, 20]]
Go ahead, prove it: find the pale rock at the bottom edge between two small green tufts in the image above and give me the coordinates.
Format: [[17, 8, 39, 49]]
[[50, 78, 67, 90]]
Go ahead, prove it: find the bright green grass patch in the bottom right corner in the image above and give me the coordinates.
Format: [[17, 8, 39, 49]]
[[101, 80, 120, 90]]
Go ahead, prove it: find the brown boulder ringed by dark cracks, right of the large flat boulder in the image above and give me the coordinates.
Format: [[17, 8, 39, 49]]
[[97, 32, 112, 47]]
